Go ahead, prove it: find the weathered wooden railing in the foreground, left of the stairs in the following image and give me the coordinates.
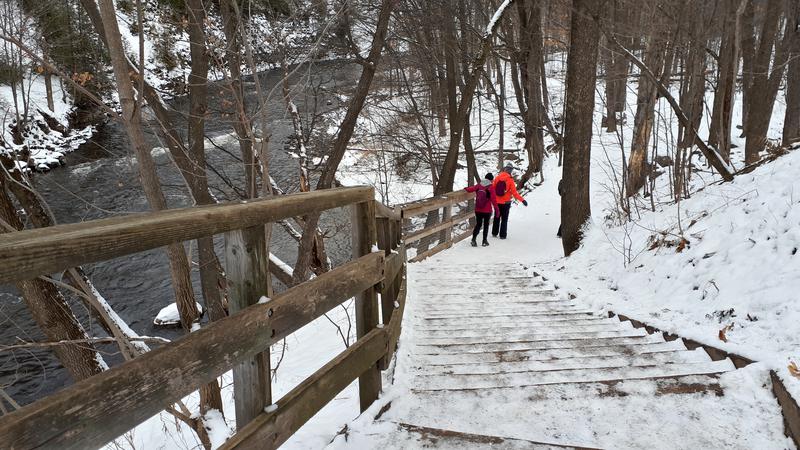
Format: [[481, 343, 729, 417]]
[[0, 187, 406, 449]]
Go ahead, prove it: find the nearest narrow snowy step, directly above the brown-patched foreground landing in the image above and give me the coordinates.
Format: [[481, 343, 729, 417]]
[[413, 359, 736, 391]]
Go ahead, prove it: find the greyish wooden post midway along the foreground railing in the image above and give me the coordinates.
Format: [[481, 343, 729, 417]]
[[225, 224, 272, 429]]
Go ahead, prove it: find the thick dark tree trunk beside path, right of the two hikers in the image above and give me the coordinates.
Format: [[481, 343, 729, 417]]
[[561, 0, 599, 256]]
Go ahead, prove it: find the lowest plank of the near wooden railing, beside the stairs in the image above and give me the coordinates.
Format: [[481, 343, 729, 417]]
[[220, 328, 387, 450]]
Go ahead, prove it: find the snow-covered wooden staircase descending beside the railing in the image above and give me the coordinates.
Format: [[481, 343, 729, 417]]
[[329, 253, 792, 449]]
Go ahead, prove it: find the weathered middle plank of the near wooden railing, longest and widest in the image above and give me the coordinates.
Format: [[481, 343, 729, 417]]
[[0, 252, 384, 449]]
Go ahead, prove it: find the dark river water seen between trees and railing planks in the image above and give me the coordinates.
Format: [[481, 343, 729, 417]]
[[0, 59, 358, 404]]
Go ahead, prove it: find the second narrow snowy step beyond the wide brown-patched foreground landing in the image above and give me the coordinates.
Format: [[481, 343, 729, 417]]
[[412, 340, 686, 367]]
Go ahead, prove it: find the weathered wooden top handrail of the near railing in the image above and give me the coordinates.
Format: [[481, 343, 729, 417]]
[[0, 187, 374, 284]]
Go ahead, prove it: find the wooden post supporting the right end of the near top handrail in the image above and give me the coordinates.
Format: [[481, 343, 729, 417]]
[[351, 200, 381, 412]]
